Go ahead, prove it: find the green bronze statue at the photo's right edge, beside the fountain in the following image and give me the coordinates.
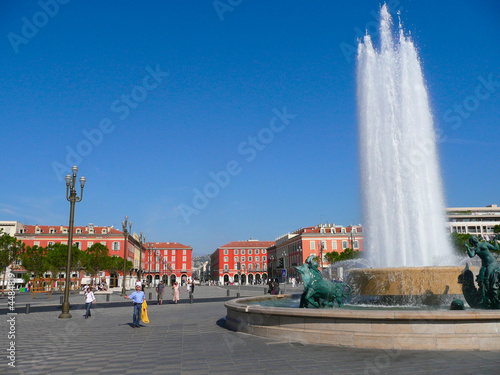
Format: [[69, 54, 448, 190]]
[[458, 235, 500, 309]]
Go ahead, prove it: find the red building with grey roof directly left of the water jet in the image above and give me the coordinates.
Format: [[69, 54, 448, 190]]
[[267, 224, 363, 281]]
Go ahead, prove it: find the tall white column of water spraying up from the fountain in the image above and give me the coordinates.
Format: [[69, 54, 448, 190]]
[[357, 5, 453, 267]]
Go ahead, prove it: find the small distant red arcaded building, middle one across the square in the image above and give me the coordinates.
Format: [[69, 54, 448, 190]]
[[210, 240, 274, 284]]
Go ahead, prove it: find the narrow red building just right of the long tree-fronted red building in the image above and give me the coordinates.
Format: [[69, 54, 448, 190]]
[[143, 242, 193, 285]]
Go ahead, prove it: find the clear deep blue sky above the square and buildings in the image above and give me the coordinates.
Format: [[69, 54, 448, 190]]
[[0, 0, 500, 254]]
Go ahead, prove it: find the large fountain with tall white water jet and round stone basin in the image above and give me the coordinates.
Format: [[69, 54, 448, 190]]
[[226, 5, 500, 350]]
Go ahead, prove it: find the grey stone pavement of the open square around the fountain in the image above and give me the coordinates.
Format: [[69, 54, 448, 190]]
[[0, 286, 500, 375]]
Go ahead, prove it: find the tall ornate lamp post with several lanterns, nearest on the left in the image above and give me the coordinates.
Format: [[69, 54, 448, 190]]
[[59, 165, 87, 319]]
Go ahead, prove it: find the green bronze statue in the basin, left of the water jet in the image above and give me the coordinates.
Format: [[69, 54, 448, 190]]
[[295, 255, 352, 308]]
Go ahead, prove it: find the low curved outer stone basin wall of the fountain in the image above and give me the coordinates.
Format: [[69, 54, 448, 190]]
[[225, 295, 500, 350]]
